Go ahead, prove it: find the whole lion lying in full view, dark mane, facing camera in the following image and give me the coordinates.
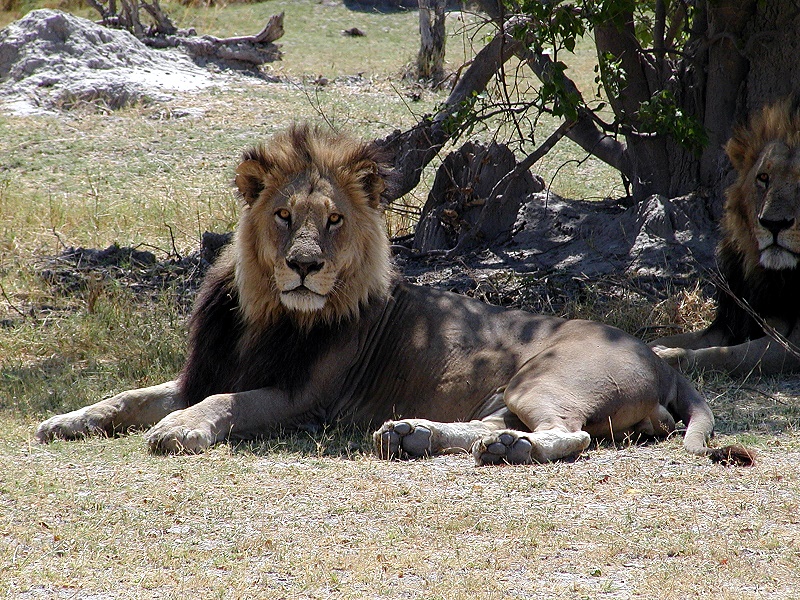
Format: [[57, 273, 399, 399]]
[[36, 125, 753, 465]]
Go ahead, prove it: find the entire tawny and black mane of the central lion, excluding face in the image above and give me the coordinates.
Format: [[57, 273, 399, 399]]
[[179, 125, 394, 405]]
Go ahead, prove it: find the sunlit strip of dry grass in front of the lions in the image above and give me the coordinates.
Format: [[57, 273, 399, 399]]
[[0, 423, 800, 600]]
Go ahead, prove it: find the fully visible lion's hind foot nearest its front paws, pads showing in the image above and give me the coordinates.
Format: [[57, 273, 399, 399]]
[[372, 419, 493, 459]]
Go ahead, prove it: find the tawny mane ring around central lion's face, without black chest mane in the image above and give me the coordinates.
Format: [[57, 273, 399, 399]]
[[230, 126, 392, 330]]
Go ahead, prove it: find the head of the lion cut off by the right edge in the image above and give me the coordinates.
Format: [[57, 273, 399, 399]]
[[723, 103, 800, 270]]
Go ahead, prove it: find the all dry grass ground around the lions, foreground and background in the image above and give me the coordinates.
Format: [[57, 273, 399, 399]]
[[0, 0, 800, 600]]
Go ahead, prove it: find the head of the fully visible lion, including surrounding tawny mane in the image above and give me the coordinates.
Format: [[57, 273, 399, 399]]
[[231, 128, 391, 326]]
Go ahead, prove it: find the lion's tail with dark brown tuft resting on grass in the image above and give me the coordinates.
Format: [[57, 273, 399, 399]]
[[673, 373, 756, 467]]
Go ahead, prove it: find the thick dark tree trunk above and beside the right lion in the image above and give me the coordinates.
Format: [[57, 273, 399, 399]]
[[595, 0, 800, 209]]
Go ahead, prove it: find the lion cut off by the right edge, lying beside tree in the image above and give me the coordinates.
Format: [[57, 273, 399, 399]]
[[651, 100, 800, 375]]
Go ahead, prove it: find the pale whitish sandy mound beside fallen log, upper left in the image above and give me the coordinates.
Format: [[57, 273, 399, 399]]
[[0, 9, 216, 114]]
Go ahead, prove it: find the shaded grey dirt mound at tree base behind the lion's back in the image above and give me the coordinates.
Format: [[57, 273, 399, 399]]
[[397, 192, 717, 313]]
